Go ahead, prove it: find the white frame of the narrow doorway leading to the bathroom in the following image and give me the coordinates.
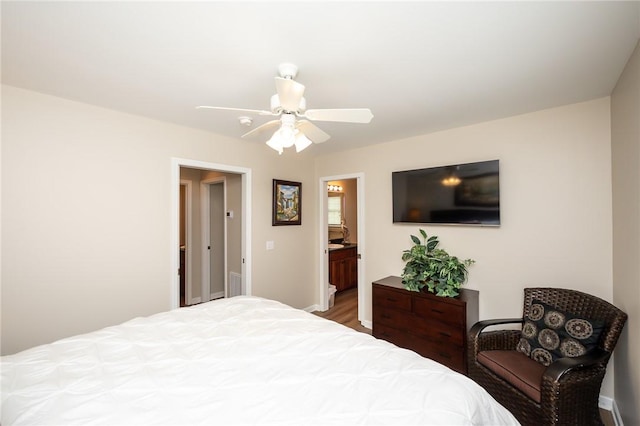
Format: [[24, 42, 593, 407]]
[[318, 172, 371, 328]]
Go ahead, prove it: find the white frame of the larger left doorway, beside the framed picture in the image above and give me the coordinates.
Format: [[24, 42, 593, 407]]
[[168, 157, 252, 309]]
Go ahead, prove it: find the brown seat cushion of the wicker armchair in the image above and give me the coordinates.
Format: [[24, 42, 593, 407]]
[[477, 351, 546, 403]]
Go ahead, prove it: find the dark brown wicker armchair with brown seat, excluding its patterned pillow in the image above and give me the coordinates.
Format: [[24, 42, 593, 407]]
[[468, 288, 627, 426]]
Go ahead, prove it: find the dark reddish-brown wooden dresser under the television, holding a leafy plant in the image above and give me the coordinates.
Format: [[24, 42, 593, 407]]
[[372, 277, 478, 374]]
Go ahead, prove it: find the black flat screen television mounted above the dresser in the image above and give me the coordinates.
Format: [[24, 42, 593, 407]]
[[392, 160, 500, 226]]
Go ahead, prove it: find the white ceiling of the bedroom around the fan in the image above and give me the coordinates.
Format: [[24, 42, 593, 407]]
[[1, 1, 640, 154]]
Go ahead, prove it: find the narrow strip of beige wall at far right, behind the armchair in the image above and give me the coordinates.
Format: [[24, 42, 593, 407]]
[[611, 38, 640, 425]]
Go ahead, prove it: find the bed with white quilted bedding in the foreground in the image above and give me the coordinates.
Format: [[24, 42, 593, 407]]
[[1, 296, 518, 426]]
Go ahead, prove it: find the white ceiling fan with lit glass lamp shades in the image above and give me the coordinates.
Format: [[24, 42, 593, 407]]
[[197, 63, 373, 154]]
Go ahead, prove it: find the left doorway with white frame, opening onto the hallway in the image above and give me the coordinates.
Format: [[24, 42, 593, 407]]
[[169, 158, 251, 309]]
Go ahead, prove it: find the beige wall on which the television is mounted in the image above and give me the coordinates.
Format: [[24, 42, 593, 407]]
[[316, 98, 613, 396]]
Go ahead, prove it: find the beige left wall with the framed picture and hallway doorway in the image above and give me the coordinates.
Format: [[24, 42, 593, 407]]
[[1, 86, 317, 354]]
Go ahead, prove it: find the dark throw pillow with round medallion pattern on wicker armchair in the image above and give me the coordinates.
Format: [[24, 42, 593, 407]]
[[516, 300, 604, 365]]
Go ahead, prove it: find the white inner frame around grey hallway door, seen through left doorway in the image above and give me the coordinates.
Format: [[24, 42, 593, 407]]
[[200, 176, 229, 302]]
